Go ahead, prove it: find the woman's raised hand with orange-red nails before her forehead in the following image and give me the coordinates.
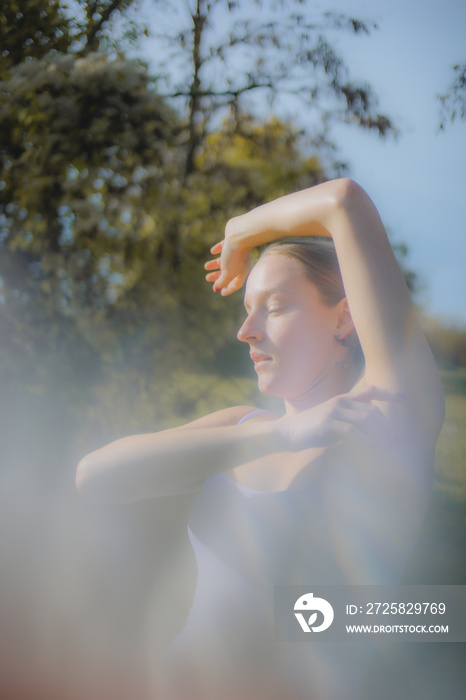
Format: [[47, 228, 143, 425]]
[[204, 227, 251, 296]]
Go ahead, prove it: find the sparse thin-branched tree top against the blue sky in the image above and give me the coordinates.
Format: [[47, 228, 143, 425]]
[[140, 0, 395, 182]]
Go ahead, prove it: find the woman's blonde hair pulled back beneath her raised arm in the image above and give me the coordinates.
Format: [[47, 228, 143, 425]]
[[259, 236, 364, 367]]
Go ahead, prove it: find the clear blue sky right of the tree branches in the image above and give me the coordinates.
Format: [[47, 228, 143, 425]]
[[140, 0, 466, 326]]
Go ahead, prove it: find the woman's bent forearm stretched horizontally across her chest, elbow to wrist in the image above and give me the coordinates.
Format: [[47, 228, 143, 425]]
[[76, 421, 282, 503]]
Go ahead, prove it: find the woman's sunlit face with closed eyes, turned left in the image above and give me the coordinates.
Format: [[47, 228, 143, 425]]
[[238, 253, 339, 399]]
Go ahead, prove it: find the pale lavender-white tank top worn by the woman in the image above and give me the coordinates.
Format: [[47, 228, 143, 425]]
[[162, 410, 416, 700]]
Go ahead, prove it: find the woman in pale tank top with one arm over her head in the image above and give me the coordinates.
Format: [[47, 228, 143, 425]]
[[77, 179, 443, 700]]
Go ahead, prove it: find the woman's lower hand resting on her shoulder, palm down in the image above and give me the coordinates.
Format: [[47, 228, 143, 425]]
[[276, 386, 404, 452]]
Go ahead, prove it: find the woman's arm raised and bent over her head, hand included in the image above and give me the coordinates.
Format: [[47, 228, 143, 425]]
[[206, 178, 443, 441]]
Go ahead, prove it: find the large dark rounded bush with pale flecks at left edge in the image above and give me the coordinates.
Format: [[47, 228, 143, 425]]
[[0, 53, 176, 388]]
